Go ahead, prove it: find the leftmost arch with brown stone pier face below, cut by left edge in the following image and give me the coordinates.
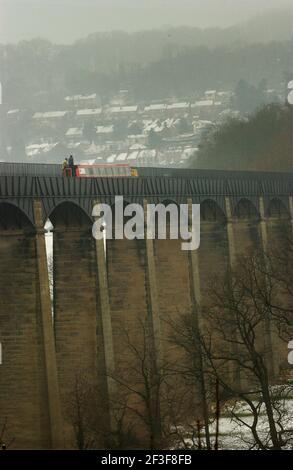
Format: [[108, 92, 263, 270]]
[[0, 202, 51, 449]]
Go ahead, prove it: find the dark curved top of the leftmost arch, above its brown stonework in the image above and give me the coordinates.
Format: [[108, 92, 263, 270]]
[[0, 202, 34, 231]]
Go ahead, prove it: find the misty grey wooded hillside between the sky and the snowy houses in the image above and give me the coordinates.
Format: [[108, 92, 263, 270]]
[[0, 9, 293, 109]]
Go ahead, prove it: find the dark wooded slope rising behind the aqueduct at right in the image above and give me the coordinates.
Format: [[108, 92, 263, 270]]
[[192, 104, 293, 171]]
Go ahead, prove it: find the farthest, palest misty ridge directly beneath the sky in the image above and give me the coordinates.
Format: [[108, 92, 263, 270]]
[[58, 8, 293, 64]]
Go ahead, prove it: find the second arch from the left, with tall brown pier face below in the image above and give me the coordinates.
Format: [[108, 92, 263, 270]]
[[49, 201, 106, 446]]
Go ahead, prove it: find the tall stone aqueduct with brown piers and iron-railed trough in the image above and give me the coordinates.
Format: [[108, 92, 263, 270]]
[[0, 171, 293, 449]]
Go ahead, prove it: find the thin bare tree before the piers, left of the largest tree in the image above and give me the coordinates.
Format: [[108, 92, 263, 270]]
[[111, 318, 174, 449]]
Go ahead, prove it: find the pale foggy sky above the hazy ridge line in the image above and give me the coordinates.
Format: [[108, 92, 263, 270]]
[[0, 0, 292, 43]]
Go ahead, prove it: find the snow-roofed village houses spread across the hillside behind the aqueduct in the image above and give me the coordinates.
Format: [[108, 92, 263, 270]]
[[2, 90, 231, 164]]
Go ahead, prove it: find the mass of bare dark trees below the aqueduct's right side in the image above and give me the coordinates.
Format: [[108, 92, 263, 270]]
[[64, 241, 293, 450]]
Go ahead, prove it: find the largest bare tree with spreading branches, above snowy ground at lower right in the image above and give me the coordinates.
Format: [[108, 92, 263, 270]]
[[201, 254, 291, 449]]
